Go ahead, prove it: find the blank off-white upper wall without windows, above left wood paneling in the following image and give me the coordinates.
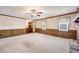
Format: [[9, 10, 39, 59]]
[[0, 15, 27, 30]]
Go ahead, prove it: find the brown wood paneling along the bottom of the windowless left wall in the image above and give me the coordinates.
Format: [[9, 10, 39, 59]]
[[0, 29, 28, 38]]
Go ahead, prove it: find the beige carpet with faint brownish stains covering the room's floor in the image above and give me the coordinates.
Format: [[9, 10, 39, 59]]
[[0, 33, 75, 53]]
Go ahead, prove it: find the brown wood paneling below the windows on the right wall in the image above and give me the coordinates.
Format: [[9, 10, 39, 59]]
[[36, 28, 77, 39]]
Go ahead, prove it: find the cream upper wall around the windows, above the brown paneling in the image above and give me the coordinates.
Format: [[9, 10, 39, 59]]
[[36, 14, 77, 30]]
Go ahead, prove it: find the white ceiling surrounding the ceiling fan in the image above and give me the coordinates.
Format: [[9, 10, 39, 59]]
[[0, 6, 77, 20]]
